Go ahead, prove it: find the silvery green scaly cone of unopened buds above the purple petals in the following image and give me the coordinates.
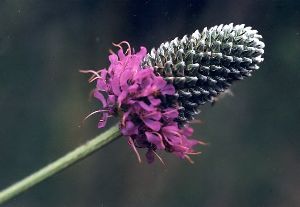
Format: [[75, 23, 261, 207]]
[[144, 24, 265, 124]]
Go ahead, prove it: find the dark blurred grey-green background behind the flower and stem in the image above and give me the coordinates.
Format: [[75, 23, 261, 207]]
[[0, 0, 300, 207]]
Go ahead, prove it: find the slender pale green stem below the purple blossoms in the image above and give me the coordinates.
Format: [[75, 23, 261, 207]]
[[0, 125, 121, 205]]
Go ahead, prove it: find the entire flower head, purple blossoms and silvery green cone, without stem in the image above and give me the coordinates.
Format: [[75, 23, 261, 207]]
[[84, 24, 264, 162]]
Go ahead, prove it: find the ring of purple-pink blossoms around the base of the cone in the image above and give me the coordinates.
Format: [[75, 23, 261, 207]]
[[82, 41, 202, 163]]
